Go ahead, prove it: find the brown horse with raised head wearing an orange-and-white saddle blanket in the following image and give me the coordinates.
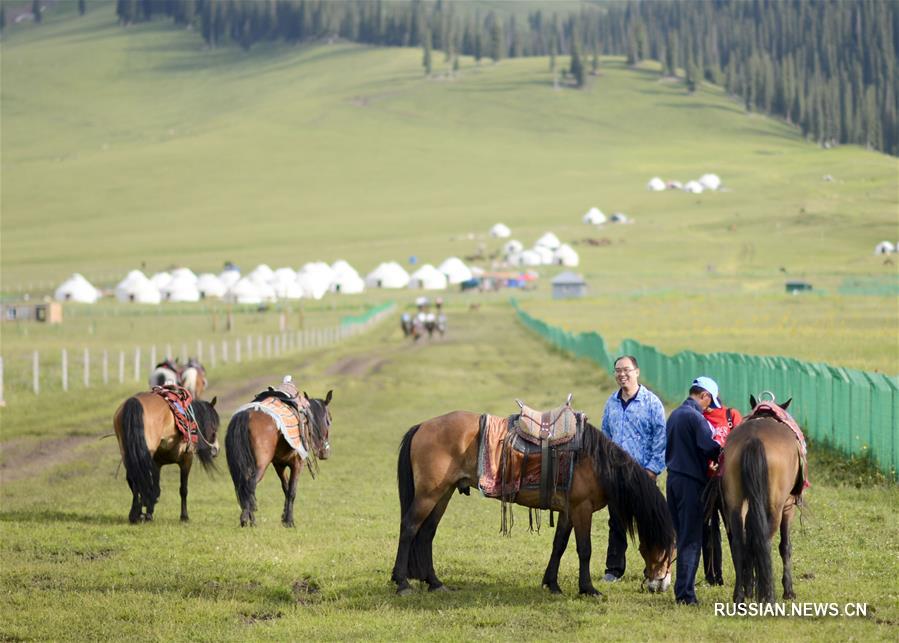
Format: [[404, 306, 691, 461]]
[[225, 391, 333, 527]]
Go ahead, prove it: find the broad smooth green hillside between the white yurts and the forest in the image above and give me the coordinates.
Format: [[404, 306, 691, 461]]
[[0, 10, 897, 289]]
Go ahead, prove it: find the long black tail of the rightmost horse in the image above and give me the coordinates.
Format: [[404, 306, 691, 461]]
[[740, 437, 774, 602]]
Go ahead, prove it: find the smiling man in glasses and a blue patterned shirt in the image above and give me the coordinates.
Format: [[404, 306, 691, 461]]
[[602, 355, 665, 583]]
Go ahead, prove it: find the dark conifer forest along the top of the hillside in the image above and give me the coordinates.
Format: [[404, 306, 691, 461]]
[[5, 0, 899, 155]]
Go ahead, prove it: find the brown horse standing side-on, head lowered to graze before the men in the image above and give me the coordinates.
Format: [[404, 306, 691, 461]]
[[392, 411, 674, 595]]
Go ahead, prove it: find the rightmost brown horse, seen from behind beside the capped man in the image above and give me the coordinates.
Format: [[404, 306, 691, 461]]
[[722, 397, 804, 603]]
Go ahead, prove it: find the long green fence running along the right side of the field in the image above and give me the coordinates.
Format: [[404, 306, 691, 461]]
[[512, 300, 899, 478]]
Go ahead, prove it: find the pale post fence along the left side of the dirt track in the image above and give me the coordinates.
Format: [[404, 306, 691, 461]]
[[0, 302, 394, 406]]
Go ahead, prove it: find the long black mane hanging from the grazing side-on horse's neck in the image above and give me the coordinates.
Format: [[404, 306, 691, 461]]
[[581, 422, 674, 552]]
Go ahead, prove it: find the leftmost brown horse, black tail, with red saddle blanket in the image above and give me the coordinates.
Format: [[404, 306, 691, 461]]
[[113, 391, 219, 523]]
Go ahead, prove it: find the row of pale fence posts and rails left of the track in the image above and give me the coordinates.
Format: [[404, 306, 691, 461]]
[[0, 302, 395, 406]]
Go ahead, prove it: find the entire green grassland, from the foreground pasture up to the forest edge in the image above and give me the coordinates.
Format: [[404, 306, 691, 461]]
[[0, 2, 899, 641]]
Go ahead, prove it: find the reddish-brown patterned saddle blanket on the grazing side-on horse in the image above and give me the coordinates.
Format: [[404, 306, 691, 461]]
[[478, 415, 574, 499]]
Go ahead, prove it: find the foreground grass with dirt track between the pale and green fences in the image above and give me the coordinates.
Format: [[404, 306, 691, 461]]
[[0, 306, 899, 641]]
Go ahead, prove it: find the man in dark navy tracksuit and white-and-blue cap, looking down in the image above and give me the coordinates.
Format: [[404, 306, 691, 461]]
[[665, 377, 721, 605]]
